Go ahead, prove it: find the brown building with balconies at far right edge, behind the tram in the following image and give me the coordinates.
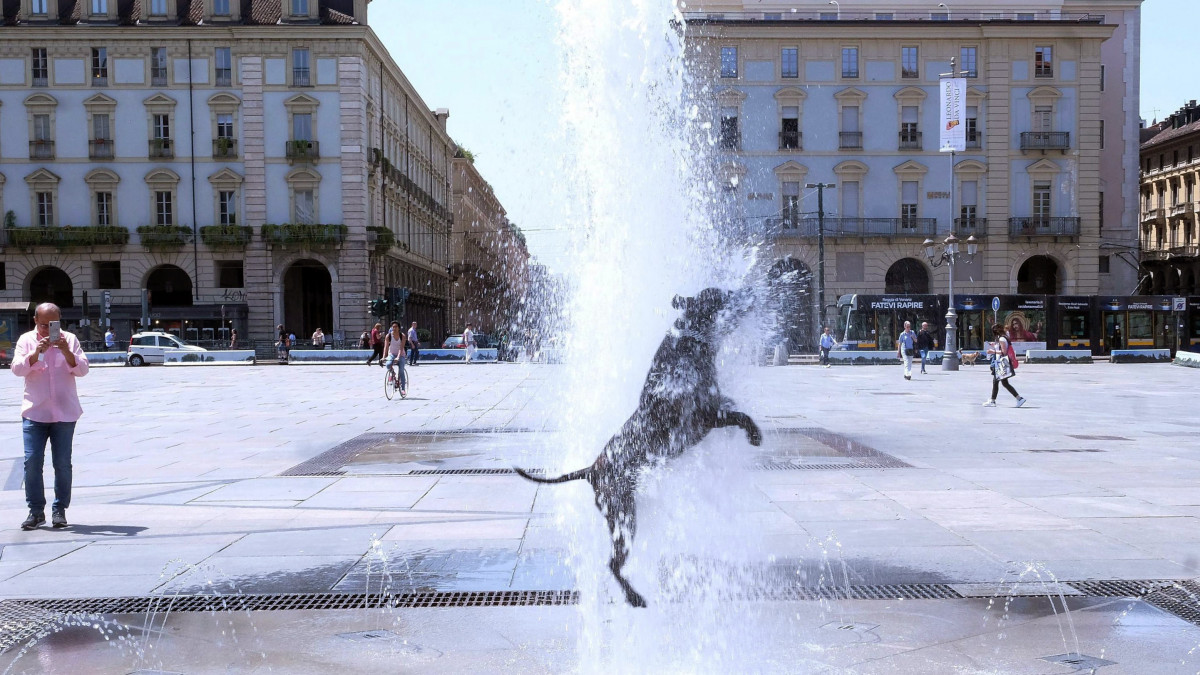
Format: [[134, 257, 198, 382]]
[[1141, 101, 1200, 295]]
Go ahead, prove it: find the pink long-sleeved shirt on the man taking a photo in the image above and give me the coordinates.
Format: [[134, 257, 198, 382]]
[[12, 330, 88, 422]]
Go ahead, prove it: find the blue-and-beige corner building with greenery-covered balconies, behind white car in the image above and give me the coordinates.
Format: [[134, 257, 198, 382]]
[[0, 0, 454, 340]]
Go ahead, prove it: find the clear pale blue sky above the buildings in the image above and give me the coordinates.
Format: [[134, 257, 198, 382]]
[[370, 0, 1200, 268]]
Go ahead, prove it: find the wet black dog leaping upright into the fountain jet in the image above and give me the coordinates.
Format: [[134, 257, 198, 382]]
[[516, 288, 762, 607]]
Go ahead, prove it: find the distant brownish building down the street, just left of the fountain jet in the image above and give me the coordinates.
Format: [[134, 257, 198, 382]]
[[450, 153, 529, 334]]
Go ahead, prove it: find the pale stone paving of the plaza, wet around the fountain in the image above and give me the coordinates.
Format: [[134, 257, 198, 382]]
[[0, 363, 1200, 675]]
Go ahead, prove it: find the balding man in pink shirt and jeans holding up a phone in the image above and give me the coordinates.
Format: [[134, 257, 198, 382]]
[[12, 303, 88, 530]]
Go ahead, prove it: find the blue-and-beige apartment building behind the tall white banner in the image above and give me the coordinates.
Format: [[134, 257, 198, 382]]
[[684, 0, 1140, 333]]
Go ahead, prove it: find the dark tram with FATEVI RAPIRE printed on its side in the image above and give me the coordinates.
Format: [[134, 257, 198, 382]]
[[838, 294, 1200, 354]]
